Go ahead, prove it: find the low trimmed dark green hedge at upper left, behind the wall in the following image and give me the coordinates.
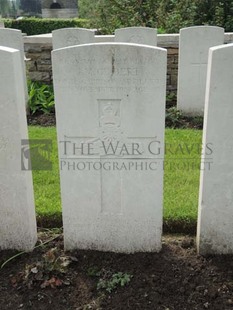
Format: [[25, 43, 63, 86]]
[[1, 17, 89, 36]]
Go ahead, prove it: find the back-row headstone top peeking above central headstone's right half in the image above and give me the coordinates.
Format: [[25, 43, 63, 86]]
[[115, 27, 157, 46]]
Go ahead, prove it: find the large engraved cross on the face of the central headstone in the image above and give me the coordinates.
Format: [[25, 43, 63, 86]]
[[64, 99, 156, 215]]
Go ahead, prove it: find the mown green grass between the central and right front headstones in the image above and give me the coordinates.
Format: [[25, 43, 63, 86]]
[[164, 129, 202, 228]]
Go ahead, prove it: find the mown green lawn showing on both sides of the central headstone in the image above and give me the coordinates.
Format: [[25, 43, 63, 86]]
[[29, 126, 202, 232]]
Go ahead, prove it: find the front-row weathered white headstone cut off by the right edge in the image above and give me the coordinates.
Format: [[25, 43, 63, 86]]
[[197, 44, 233, 254]]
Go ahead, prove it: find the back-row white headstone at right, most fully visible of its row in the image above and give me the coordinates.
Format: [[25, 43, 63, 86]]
[[177, 26, 224, 115]]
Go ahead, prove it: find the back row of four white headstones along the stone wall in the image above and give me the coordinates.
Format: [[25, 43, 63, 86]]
[[0, 26, 228, 115]]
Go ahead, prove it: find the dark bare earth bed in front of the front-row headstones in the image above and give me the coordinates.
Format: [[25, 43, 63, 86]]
[[0, 234, 233, 310]]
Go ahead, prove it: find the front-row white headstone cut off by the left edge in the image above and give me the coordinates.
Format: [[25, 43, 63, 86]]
[[0, 47, 37, 251]]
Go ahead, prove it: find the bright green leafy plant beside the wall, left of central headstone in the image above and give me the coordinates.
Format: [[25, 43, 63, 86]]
[[28, 81, 55, 114]]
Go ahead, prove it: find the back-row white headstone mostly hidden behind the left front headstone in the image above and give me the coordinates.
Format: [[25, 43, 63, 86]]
[[0, 28, 28, 112]]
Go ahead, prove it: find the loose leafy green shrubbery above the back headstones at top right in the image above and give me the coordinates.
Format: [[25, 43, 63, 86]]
[[79, 0, 233, 34]]
